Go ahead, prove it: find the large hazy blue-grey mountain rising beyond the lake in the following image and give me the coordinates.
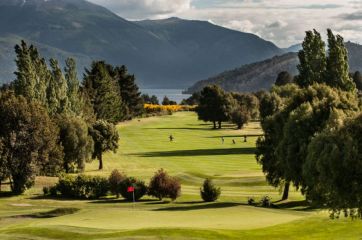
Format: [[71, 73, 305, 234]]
[[0, 0, 286, 88]]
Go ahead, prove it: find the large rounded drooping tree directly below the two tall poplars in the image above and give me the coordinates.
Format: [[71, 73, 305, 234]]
[[257, 84, 358, 200]]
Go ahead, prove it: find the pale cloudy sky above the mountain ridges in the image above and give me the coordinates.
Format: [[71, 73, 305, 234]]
[[90, 0, 362, 47]]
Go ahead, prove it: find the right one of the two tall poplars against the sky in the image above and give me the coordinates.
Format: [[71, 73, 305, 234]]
[[325, 29, 355, 91]]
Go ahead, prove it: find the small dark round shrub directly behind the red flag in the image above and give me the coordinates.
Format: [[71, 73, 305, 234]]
[[119, 177, 147, 201]]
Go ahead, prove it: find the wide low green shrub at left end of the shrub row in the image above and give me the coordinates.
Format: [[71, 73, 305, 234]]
[[49, 175, 109, 199]]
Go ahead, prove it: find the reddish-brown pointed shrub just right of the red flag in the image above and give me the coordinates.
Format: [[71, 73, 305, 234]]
[[148, 169, 181, 201]]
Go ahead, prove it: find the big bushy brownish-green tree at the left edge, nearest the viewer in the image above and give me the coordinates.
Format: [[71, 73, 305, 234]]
[[0, 92, 62, 194]]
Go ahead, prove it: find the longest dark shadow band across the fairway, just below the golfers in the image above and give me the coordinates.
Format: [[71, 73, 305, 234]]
[[130, 148, 255, 157]]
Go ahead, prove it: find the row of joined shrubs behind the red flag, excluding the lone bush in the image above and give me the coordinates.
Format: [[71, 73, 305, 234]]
[[43, 169, 181, 201]]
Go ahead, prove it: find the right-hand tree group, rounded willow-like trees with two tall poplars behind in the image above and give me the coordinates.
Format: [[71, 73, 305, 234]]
[[256, 30, 362, 218]]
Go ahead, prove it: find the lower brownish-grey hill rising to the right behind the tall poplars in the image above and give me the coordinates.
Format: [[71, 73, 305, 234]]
[[185, 42, 362, 93]]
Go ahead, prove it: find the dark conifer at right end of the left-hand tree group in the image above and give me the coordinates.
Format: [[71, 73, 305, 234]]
[[113, 65, 144, 118]]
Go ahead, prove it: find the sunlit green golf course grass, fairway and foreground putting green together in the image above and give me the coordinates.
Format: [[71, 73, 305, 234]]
[[0, 113, 362, 239]]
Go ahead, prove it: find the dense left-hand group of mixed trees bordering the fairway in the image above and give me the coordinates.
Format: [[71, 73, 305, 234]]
[[0, 41, 144, 194]]
